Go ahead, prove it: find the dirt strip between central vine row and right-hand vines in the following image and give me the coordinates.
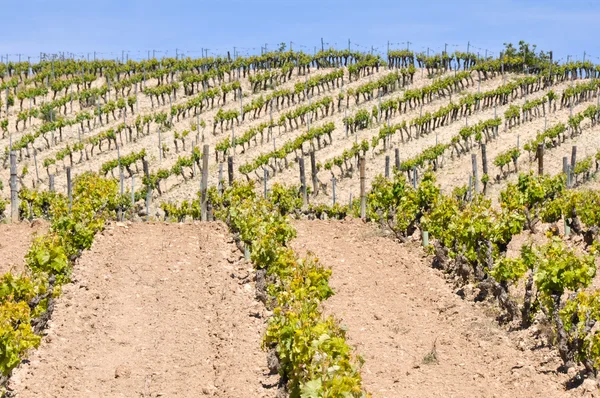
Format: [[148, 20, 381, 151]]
[[292, 220, 594, 398]]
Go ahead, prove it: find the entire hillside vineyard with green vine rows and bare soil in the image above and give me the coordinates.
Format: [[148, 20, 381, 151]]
[[0, 42, 600, 397]]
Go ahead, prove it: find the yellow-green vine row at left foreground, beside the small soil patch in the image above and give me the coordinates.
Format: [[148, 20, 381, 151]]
[[0, 173, 122, 375]]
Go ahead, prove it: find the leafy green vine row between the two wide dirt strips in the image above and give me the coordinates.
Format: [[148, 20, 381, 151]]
[[208, 181, 365, 397]]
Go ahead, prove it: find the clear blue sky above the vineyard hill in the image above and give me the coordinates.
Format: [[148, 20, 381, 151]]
[[0, 0, 600, 63]]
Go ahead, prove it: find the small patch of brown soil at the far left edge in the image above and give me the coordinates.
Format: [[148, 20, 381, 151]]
[[0, 221, 48, 275]]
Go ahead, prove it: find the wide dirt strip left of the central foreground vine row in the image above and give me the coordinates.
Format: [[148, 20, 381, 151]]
[[11, 223, 277, 398]]
